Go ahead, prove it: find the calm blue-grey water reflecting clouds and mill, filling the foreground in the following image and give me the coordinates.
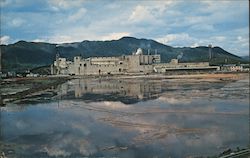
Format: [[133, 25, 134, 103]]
[[0, 76, 249, 158]]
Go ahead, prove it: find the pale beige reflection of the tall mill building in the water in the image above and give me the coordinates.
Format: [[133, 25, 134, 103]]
[[61, 79, 162, 102]]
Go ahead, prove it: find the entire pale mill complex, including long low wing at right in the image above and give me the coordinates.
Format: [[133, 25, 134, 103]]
[[51, 48, 219, 75]]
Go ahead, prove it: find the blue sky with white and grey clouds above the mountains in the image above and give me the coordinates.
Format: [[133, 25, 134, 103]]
[[0, 0, 249, 56]]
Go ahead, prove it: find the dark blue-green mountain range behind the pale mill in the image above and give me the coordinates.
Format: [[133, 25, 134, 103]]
[[0, 37, 246, 72]]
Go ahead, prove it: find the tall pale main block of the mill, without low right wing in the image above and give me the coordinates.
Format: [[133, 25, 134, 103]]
[[51, 48, 161, 75]]
